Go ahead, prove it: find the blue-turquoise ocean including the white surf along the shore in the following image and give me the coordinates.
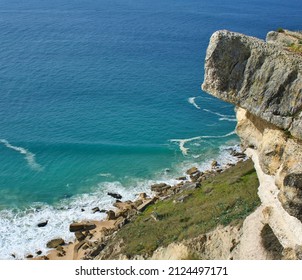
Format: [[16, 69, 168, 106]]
[[0, 0, 302, 259]]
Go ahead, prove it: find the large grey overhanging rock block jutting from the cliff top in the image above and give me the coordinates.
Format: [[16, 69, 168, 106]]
[[202, 30, 302, 139]]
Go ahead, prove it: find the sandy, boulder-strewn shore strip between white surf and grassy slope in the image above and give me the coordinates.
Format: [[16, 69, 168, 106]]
[[31, 147, 248, 260]]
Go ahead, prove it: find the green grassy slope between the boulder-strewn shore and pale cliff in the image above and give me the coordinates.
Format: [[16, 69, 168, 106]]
[[115, 160, 260, 257]]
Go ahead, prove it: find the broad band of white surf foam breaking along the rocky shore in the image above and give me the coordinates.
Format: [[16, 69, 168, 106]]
[[1, 143, 240, 260]]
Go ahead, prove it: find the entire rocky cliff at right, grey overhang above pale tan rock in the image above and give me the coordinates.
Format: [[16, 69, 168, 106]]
[[202, 30, 302, 259]]
